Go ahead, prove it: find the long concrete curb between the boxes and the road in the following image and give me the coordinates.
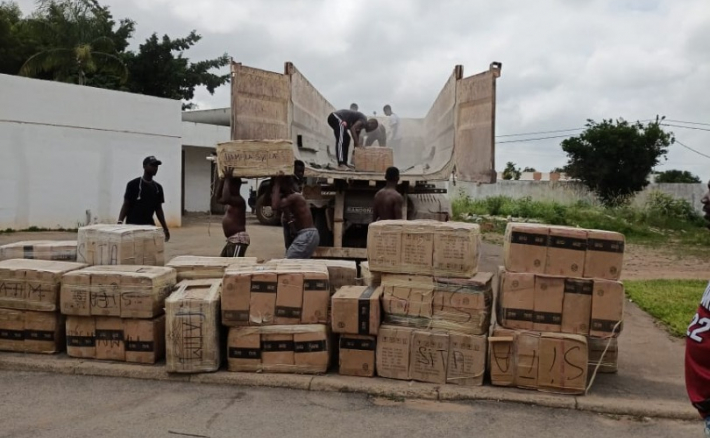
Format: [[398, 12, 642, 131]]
[[0, 353, 699, 420]]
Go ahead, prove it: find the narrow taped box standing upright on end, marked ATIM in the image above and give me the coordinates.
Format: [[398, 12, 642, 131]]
[[165, 280, 222, 373]]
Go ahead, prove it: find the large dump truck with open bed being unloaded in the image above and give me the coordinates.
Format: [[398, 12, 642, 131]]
[[230, 62, 502, 260]]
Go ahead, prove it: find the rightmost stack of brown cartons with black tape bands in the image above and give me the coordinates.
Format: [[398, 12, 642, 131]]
[[490, 223, 624, 393]]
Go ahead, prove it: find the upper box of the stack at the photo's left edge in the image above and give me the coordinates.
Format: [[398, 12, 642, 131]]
[[0, 259, 86, 312]]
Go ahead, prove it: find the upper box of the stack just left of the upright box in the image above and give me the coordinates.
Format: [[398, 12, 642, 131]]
[[60, 265, 176, 319]]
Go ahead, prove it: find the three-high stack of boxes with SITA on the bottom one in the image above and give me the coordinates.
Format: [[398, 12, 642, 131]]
[[364, 221, 492, 386]]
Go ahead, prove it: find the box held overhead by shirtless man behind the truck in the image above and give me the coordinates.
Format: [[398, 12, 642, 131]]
[[217, 140, 296, 178]]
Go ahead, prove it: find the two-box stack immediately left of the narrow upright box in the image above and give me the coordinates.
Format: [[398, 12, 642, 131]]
[[60, 265, 176, 364]]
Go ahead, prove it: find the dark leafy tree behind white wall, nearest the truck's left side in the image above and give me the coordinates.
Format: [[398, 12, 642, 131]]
[[126, 30, 230, 109]]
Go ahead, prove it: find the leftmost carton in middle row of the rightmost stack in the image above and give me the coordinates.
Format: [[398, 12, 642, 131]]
[[499, 272, 535, 330]]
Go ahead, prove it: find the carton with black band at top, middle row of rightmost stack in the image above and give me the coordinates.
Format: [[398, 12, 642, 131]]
[[560, 278, 594, 335]]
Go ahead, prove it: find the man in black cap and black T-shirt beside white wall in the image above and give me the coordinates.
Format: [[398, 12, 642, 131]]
[[118, 155, 170, 242]]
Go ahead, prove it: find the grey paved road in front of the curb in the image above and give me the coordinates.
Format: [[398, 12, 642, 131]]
[[0, 372, 702, 438]]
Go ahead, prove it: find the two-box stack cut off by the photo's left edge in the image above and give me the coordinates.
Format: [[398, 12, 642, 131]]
[[0, 259, 86, 353]]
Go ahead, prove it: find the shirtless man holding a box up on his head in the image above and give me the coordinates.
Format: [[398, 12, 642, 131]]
[[217, 168, 250, 257]]
